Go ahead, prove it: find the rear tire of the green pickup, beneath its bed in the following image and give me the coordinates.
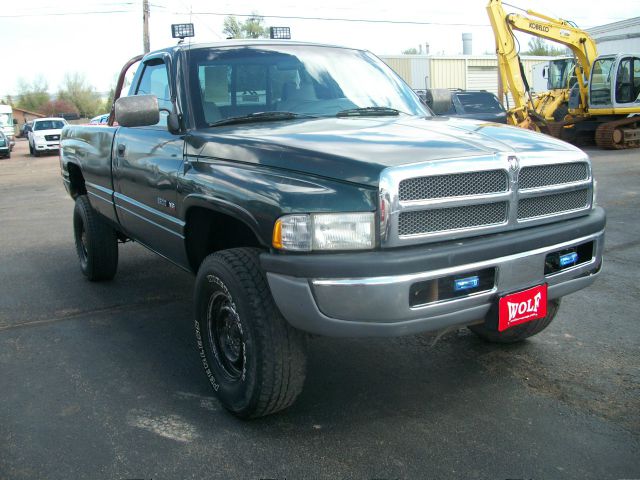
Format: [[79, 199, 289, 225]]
[[73, 195, 118, 282]]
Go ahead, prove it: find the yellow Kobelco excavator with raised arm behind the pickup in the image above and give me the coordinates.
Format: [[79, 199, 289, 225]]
[[487, 0, 640, 149]]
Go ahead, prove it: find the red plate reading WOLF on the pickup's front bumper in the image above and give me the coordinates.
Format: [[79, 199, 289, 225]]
[[498, 283, 547, 332]]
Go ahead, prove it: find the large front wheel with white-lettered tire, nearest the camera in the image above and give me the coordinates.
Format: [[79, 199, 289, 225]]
[[195, 248, 306, 418]]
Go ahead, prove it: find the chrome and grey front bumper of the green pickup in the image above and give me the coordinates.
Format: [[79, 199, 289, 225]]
[[261, 208, 605, 337]]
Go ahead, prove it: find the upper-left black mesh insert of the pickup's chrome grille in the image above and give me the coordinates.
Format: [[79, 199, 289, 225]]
[[399, 170, 509, 201]]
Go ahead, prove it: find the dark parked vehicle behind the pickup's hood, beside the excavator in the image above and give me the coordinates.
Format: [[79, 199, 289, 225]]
[[416, 89, 507, 123]]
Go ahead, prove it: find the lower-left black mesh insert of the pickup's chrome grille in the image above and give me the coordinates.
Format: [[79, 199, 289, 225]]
[[398, 202, 508, 237]]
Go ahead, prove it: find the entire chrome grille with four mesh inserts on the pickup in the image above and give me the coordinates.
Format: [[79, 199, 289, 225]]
[[380, 151, 593, 248]]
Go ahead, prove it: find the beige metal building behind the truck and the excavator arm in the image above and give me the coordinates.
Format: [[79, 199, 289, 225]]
[[380, 55, 549, 100]]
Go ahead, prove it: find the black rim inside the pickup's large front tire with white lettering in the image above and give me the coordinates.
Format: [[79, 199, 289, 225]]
[[207, 291, 245, 380]]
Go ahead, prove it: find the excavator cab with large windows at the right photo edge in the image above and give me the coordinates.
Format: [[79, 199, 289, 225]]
[[589, 54, 640, 110]]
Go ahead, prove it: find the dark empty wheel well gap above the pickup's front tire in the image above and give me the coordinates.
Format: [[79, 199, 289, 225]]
[[185, 207, 263, 272]]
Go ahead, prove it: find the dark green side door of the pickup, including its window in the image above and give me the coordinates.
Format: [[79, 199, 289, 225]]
[[113, 55, 186, 264]]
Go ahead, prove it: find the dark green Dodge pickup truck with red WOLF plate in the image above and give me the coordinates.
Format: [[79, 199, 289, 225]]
[[61, 40, 605, 418]]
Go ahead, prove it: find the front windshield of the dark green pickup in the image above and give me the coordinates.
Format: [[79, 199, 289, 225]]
[[188, 45, 429, 126]]
